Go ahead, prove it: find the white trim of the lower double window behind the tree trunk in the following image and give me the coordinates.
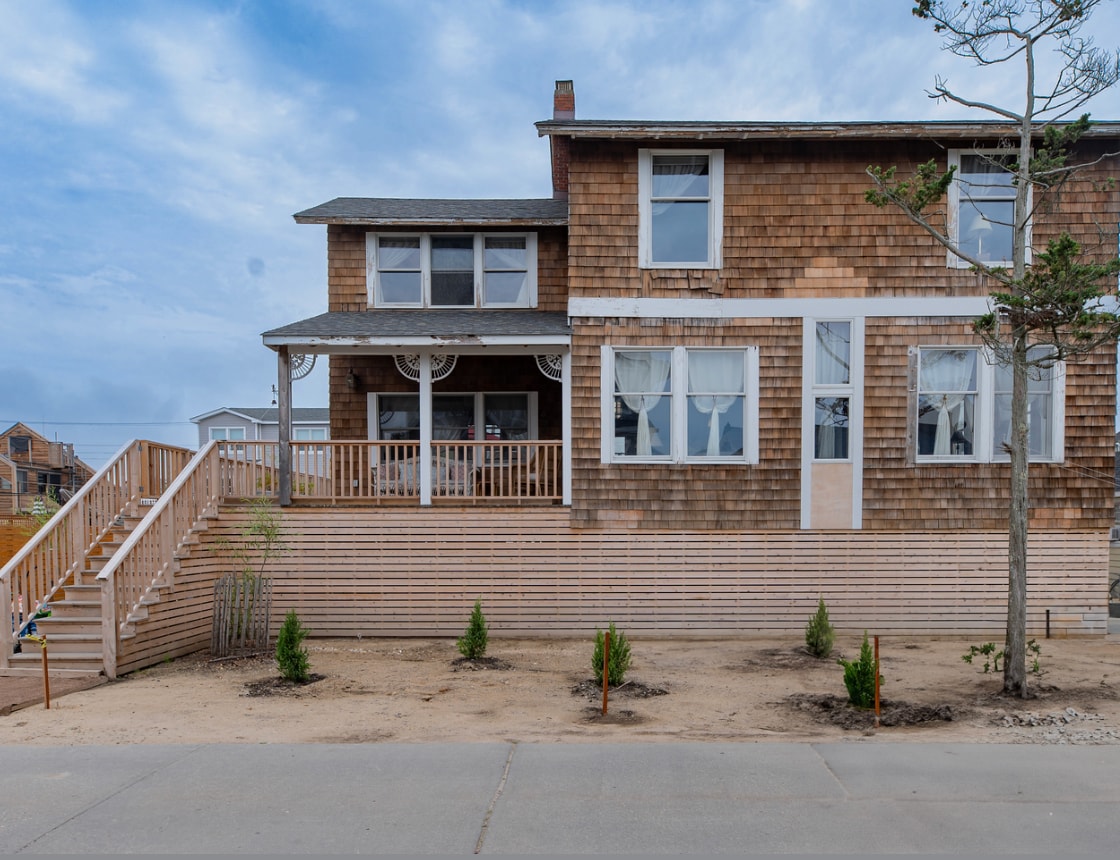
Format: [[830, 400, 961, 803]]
[[911, 344, 1065, 466]]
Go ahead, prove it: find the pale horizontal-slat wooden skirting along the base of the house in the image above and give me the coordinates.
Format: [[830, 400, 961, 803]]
[[157, 507, 1109, 653]]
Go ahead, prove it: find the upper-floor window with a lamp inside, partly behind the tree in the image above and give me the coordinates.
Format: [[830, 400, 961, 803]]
[[949, 149, 1030, 268]]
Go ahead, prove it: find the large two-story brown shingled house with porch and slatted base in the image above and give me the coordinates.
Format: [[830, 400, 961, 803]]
[[254, 82, 1120, 633]]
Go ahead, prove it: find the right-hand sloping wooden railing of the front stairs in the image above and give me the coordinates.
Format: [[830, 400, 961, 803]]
[[97, 442, 223, 677]]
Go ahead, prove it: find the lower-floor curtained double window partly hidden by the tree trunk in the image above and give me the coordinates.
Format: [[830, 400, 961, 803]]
[[916, 347, 1064, 462]]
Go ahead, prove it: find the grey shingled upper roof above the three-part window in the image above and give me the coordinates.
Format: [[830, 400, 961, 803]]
[[292, 197, 568, 226]]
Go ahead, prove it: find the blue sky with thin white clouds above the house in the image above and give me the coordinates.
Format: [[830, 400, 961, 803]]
[[0, 0, 1120, 466]]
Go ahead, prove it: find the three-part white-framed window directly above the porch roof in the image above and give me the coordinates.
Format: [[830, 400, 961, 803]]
[[366, 233, 536, 308]]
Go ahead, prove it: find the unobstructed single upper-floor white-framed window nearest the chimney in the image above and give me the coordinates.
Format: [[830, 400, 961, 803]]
[[638, 149, 724, 269]]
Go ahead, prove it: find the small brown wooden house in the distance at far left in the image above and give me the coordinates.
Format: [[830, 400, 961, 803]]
[[0, 423, 93, 514]]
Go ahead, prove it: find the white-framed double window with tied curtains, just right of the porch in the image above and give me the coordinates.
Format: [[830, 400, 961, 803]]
[[603, 346, 758, 462]]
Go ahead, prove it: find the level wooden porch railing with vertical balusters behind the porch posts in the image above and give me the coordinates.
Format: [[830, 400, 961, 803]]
[[212, 439, 562, 504]]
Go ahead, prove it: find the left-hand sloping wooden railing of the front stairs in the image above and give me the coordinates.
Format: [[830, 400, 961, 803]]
[[0, 440, 190, 666]]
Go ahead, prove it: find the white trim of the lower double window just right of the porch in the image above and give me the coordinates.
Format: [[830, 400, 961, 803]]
[[599, 345, 758, 466]]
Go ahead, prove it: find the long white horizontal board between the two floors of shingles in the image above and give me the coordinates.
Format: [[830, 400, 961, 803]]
[[568, 296, 989, 319]]
